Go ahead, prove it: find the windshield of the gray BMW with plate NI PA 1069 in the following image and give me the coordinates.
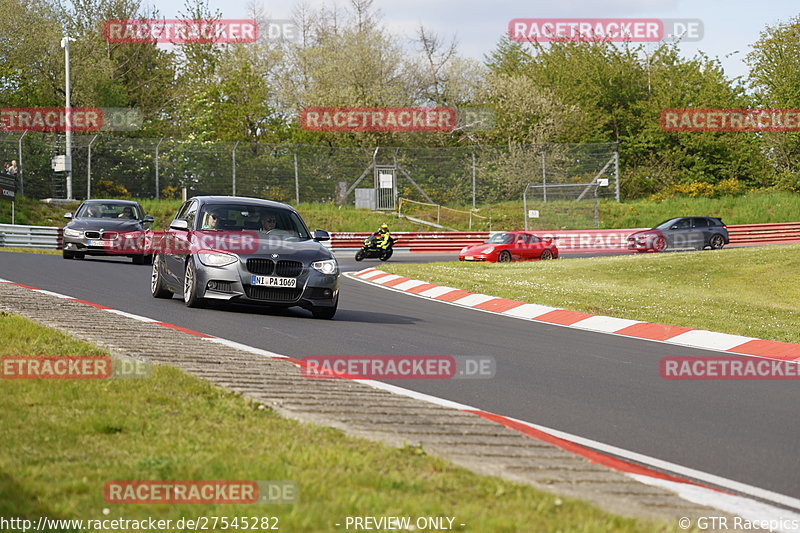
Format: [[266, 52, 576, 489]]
[[200, 204, 311, 240]]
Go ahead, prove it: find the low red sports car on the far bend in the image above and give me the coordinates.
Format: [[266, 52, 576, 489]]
[[458, 231, 558, 263]]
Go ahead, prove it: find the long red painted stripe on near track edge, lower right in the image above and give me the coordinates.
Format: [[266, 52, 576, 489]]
[[464, 409, 716, 494]]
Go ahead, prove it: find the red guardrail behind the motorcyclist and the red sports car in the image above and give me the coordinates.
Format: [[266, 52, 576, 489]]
[[331, 222, 800, 253]]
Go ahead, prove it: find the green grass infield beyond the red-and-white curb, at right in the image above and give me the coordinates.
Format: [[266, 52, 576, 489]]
[[381, 245, 800, 342]]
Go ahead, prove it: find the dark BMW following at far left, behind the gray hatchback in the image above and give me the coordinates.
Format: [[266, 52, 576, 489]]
[[61, 200, 153, 265]]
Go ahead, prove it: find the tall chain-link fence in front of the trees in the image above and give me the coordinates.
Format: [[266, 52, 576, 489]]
[[0, 132, 619, 207]]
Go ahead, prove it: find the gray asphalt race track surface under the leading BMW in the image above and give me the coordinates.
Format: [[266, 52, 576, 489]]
[[0, 252, 800, 498]]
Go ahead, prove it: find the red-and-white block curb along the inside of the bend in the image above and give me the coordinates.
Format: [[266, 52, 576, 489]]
[[350, 268, 800, 363]]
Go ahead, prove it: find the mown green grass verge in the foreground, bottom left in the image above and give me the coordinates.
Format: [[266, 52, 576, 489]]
[[0, 313, 668, 532]]
